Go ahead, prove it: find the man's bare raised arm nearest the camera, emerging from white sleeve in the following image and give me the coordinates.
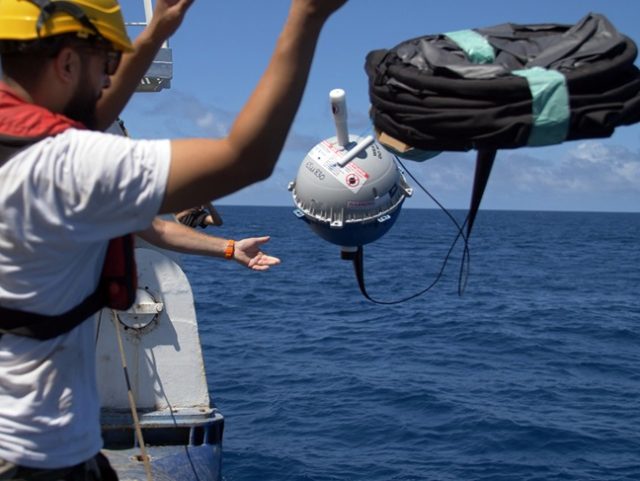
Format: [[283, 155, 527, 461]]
[[161, 0, 346, 213]]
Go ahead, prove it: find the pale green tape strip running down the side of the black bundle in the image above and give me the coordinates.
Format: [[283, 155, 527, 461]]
[[512, 67, 571, 146]]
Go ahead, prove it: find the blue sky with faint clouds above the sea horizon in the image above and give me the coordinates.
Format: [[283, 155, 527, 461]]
[[117, 0, 640, 212]]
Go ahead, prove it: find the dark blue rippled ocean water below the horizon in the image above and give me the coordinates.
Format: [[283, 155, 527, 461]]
[[180, 206, 640, 481]]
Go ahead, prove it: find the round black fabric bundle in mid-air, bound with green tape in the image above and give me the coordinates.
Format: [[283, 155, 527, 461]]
[[365, 13, 640, 151]]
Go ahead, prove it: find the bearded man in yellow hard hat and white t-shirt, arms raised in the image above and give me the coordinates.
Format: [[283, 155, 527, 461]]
[[0, 0, 346, 480]]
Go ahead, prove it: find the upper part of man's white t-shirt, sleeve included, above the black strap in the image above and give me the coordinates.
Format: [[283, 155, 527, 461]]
[[0, 129, 171, 314]]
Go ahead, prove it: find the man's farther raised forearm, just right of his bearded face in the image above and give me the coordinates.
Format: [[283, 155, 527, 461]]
[[96, 0, 193, 130]]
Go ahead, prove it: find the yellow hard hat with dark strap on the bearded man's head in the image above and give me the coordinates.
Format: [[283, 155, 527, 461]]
[[0, 0, 133, 52]]
